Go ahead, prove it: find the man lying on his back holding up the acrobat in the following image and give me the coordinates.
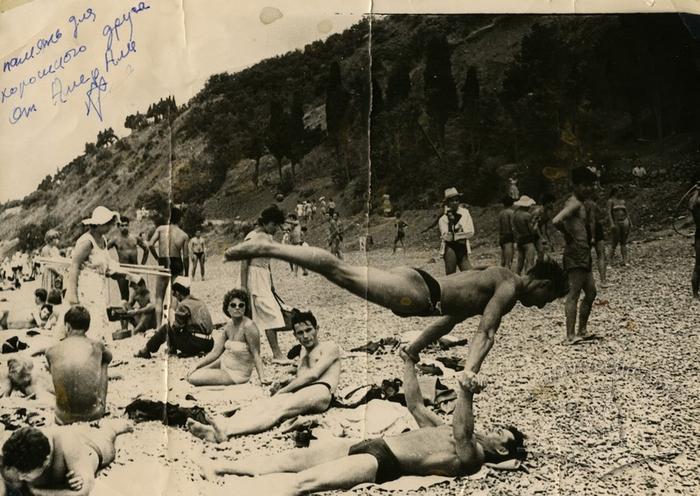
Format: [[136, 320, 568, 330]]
[[197, 350, 527, 495]]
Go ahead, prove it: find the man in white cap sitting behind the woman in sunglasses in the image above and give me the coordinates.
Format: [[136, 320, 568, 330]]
[[134, 276, 214, 358]]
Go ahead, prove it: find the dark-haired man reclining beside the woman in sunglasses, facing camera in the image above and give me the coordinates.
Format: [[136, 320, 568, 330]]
[[187, 311, 340, 443]]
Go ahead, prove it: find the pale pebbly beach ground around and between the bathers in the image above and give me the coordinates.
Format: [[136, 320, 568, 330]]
[[0, 238, 700, 495]]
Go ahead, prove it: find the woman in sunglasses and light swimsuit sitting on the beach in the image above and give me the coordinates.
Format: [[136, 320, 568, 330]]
[[187, 289, 269, 386]]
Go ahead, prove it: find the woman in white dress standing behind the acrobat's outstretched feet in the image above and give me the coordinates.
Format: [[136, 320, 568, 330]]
[[241, 205, 289, 363]]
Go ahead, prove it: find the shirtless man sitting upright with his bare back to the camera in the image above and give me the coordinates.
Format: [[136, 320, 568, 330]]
[[46, 305, 112, 424]]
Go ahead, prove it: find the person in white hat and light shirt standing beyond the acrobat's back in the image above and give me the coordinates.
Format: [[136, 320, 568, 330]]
[[438, 188, 474, 275]]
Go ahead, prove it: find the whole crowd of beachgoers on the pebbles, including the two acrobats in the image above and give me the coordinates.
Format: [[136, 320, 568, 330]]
[[0, 167, 700, 495]]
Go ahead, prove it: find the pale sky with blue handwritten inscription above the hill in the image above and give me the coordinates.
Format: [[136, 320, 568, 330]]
[[0, 0, 367, 202]]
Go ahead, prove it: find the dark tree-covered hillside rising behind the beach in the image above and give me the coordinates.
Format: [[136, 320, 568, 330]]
[[0, 15, 700, 256]]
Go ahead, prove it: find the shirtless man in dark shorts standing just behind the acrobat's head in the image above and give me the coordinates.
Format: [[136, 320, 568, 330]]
[[552, 167, 597, 344]]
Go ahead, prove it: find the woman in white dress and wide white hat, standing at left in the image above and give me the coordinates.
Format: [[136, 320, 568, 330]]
[[64, 206, 126, 340]]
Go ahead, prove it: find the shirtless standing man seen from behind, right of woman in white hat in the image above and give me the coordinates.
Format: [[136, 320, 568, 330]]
[[148, 207, 190, 327]]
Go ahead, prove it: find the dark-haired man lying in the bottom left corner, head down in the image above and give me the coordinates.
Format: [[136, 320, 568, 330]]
[[0, 419, 132, 496]]
